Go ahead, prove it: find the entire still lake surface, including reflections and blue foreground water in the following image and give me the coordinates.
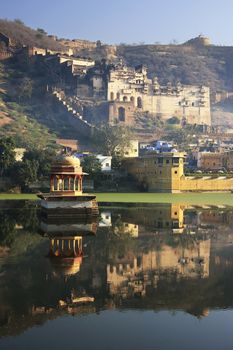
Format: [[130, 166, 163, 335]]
[[0, 203, 233, 350]]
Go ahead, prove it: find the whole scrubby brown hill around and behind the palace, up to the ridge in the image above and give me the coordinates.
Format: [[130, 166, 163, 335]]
[[0, 20, 233, 139]]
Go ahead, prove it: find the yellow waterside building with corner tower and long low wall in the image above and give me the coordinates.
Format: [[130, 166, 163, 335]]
[[124, 152, 233, 193]]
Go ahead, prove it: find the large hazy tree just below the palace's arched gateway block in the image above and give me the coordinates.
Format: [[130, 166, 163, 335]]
[[92, 124, 131, 156]]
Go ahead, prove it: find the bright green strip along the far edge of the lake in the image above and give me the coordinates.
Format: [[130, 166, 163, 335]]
[[0, 193, 233, 206]]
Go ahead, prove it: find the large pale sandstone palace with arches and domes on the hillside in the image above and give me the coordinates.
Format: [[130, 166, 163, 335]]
[[107, 65, 211, 125]]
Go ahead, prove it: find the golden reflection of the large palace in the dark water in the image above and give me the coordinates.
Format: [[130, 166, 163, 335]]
[[107, 239, 210, 298]]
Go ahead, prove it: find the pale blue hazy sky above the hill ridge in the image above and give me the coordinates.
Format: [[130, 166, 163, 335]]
[[0, 0, 233, 45]]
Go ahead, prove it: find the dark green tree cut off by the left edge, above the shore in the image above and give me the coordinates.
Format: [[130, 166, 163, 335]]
[[0, 137, 15, 176]]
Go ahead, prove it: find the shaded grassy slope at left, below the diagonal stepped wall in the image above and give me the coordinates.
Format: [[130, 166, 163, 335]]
[[0, 61, 86, 149]]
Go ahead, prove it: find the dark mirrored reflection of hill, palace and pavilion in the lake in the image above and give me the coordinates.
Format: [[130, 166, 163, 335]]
[[0, 204, 233, 342]]
